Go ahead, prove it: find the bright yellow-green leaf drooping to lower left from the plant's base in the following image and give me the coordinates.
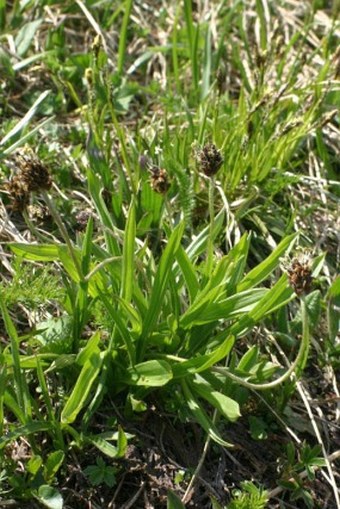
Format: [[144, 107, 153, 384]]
[[61, 350, 102, 424]]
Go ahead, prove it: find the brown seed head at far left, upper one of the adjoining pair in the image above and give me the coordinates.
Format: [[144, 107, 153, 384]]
[[16, 155, 52, 193]]
